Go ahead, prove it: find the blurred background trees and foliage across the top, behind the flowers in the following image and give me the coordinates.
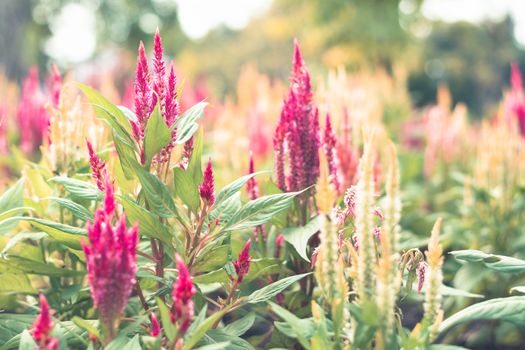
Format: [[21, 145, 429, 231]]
[[0, 0, 525, 117]]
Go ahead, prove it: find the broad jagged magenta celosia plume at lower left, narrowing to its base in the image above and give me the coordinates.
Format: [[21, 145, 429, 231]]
[[82, 182, 138, 338]]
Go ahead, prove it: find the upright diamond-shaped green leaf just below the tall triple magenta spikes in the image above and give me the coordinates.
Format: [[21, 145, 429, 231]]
[[144, 103, 171, 168]]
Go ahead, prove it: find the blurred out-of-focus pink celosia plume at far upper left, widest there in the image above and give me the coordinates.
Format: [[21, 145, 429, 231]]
[[17, 67, 49, 153]]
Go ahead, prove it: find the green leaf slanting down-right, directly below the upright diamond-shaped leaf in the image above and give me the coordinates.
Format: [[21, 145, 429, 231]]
[[135, 166, 178, 218]]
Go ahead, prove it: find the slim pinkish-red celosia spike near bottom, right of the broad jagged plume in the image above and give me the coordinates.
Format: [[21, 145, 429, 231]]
[[171, 254, 197, 334]]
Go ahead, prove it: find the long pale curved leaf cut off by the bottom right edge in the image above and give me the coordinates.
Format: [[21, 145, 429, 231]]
[[439, 296, 525, 333]]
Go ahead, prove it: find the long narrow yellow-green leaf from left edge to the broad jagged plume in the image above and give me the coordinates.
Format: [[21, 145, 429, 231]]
[[0, 216, 86, 250]]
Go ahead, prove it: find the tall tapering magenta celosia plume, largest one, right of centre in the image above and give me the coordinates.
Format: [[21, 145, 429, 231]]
[[274, 40, 320, 191]]
